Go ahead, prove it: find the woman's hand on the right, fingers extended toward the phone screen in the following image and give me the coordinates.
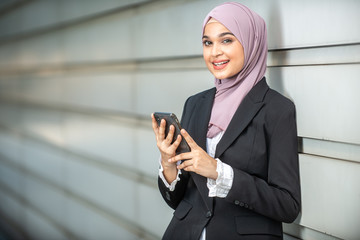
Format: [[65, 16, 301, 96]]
[[169, 129, 218, 180]]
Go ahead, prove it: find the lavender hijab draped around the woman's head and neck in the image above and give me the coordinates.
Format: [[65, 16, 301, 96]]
[[203, 2, 268, 138]]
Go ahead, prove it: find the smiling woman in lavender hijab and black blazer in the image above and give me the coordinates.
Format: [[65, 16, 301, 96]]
[[152, 3, 300, 240]]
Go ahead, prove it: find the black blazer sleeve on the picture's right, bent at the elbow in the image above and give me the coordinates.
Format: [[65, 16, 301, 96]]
[[226, 104, 301, 223]]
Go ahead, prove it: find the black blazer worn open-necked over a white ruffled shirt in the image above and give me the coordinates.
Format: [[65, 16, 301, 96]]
[[158, 78, 301, 240]]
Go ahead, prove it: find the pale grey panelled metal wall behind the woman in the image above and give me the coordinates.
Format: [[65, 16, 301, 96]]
[[0, 0, 360, 240]]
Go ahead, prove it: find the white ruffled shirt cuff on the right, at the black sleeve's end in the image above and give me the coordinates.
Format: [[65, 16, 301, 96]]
[[207, 158, 234, 198]]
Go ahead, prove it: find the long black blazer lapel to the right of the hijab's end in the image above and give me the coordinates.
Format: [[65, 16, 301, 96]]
[[215, 79, 269, 157]]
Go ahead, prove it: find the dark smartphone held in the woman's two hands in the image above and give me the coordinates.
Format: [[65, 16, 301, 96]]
[[154, 112, 190, 154]]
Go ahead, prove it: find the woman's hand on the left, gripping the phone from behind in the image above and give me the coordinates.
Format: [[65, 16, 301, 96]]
[[151, 114, 181, 173]]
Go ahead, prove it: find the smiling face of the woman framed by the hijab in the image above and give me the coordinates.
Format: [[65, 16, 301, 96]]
[[203, 20, 244, 79]]
